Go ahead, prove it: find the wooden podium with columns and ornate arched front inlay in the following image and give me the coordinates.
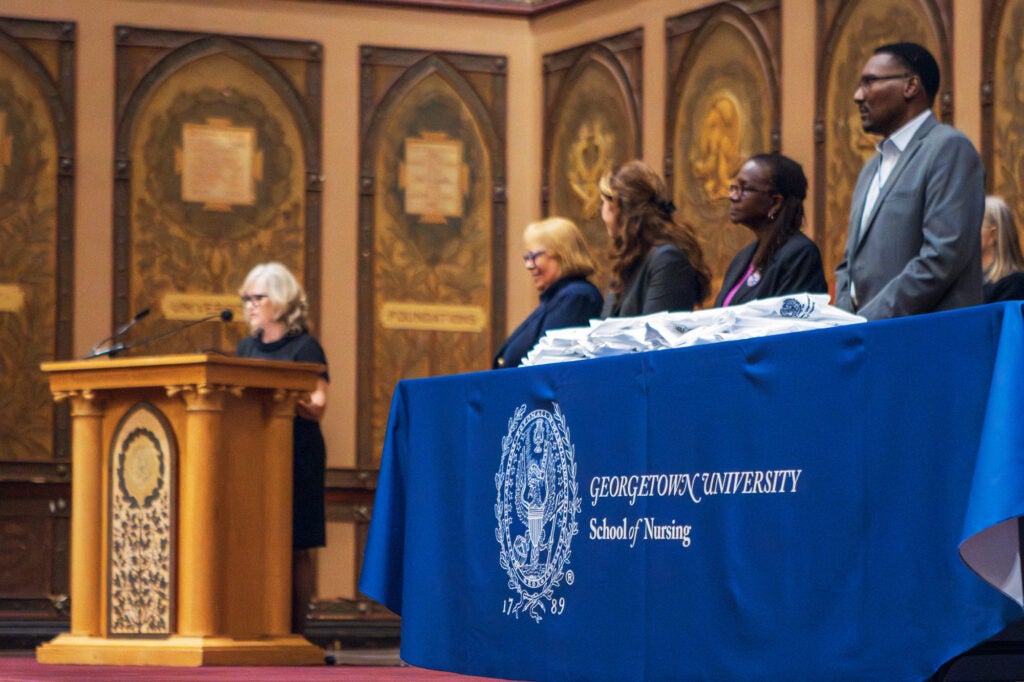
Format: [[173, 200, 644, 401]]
[[36, 354, 324, 666]]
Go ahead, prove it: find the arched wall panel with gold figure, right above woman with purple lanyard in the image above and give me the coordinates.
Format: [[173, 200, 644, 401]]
[[665, 2, 779, 305]]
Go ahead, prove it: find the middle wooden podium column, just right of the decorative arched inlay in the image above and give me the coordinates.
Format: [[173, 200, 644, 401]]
[[174, 385, 224, 637]]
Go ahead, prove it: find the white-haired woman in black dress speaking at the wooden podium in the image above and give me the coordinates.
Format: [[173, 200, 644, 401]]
[[238, 263, 330, 634]]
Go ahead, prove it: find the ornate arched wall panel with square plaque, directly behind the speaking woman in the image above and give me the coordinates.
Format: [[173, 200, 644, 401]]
[[114, 27, 323, 354]]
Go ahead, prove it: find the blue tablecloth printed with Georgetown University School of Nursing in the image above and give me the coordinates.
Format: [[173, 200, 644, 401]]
[[359, 303, 1024, 680]]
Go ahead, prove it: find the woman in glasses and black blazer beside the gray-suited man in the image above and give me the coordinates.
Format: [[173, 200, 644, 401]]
[[715, 154, 828, 307]]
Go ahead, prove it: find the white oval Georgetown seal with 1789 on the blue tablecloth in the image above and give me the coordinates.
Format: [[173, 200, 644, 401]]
[[495, 404, 580, 623]]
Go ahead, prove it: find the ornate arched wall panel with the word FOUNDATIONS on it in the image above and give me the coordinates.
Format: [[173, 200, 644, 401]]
[[357, 47, 506, 468]]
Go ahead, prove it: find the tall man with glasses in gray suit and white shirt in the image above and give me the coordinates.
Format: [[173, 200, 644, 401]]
[[836, 43, 985, 319]]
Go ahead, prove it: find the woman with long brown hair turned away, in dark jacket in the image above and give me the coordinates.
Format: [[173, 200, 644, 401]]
[[600, 161, 711, 317]]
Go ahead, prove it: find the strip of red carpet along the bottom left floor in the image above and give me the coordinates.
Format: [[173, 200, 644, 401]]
[[0, 652, 503, 682]]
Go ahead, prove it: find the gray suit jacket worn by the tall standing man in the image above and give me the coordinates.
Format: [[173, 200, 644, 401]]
[[836, 118, 985, 319]]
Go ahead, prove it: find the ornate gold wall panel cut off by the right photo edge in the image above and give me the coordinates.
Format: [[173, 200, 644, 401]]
[[982, 0, 1024, 238]]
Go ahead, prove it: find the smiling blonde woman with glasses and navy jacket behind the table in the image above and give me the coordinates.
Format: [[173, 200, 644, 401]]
[[494, 217, 601, 369]]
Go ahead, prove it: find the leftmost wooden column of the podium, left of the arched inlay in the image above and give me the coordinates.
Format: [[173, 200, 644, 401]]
[[63, 390, 105, 637]]
